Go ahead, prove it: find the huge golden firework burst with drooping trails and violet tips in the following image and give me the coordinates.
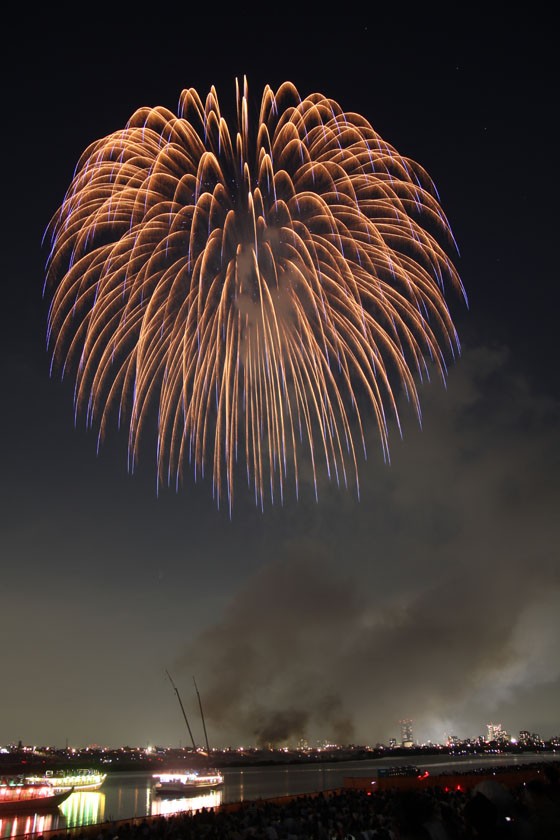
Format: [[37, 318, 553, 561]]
[[42, 79, 464, 512]]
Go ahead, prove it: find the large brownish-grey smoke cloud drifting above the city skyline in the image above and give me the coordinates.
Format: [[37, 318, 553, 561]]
[[176, 348, 560, 746]]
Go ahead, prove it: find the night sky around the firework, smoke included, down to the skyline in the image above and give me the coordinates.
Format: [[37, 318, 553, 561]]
[[0, 16, 560, 746]]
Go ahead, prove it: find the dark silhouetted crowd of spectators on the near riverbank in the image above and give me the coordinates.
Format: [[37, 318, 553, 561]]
[[41, 765, 560, 840]]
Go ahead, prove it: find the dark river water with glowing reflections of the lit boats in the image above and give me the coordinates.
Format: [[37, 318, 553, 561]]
[[0, 753, 560, 838]]
